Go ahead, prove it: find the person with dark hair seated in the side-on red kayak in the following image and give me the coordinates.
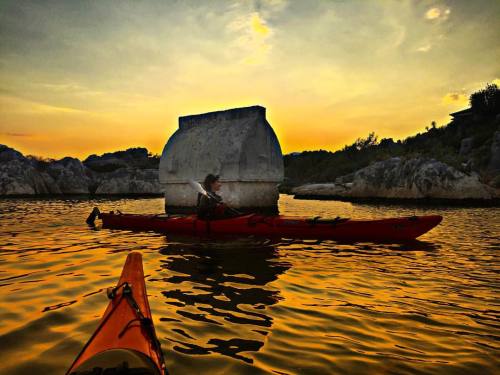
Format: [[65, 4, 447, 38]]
[[197, 174, 239, 220]]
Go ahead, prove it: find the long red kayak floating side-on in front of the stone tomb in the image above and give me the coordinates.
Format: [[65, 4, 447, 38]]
[[99, 212, 443, 241]]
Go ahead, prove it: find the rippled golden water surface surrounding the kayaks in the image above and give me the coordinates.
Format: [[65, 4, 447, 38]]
[[0, 196, 500, 375]]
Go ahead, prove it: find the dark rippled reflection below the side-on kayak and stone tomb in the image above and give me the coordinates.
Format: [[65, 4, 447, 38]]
[[150, 237, 290, 363]]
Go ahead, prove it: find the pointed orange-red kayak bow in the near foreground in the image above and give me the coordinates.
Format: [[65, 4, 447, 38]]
[[66, 253, 167, 375]]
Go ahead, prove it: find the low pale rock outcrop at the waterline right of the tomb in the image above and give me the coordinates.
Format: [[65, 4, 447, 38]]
[[293, 157, 498, 200]]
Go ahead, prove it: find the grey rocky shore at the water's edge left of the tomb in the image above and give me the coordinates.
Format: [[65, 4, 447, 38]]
[[0, 145, 162, 196]]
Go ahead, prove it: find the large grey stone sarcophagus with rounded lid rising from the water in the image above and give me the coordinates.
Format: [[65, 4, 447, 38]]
[[159, 106, 284, 213]]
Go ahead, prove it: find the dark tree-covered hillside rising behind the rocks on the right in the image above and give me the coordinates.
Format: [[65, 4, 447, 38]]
[[281, 84, 500, 192]]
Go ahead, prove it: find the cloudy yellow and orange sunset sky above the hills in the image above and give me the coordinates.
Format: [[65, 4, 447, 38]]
[[0, 0, 500, 158]]
